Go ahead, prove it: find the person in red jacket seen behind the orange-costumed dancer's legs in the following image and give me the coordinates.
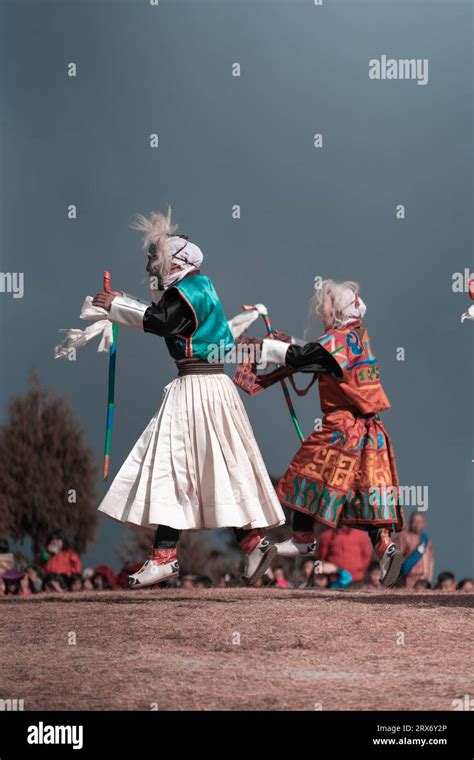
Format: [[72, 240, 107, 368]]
[[318, 525, 372, 583]]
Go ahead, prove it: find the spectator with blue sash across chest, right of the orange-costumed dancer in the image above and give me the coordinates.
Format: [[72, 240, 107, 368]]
[[394, 512, 434, 588]]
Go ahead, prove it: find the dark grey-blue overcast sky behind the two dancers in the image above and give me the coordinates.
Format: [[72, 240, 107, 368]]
[[0, 0, 474, 576]]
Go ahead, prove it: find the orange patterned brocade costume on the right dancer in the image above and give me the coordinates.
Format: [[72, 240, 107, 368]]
[[277, 321, 404, 531]]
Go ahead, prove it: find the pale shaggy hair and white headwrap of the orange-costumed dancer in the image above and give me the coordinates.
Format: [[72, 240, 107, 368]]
[[308, 280, 365, 330]]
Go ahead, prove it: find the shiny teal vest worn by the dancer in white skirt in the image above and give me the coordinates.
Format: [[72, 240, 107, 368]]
[[168, 274, 235, 361]]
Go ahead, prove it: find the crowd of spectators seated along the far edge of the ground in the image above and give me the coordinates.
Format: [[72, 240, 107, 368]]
[[0, 513, 474, 596]]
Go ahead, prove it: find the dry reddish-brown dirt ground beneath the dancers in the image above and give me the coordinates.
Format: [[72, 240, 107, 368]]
[[0, 588, 474, 710]]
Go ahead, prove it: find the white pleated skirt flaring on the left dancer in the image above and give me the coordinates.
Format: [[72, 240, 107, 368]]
[[99, 374, 285, 530]]
